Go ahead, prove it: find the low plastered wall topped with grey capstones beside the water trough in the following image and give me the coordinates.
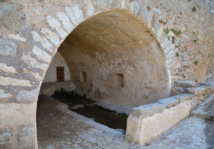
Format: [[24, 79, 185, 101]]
[[126, 86, 214, 145]]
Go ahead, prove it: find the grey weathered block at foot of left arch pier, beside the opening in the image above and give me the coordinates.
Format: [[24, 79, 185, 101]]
[[16, 124, 36, 149]]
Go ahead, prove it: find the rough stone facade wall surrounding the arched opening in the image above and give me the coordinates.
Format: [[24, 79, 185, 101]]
[[0, 0, 214, 148]]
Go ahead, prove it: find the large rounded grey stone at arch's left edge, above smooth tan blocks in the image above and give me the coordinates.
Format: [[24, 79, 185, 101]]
[[16, 89, 39, 103]]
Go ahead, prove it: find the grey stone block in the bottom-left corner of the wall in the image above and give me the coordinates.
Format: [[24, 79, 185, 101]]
[[0, 128, 12, 149]]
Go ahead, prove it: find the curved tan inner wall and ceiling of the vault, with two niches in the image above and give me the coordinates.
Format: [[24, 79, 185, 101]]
[[54, 9, 170, 107]]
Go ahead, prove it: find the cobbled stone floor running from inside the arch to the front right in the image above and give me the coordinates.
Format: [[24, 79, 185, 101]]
[[37, 96, 214, 149]]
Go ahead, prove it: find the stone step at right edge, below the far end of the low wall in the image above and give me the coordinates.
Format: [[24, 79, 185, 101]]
[[191, 93, 214, 121]]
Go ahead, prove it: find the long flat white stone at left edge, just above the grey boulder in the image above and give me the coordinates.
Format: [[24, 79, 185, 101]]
[[0, 76, 32, 87]]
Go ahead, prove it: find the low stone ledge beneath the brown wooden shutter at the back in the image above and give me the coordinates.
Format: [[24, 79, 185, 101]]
[[39, 81, 76, 96]]
